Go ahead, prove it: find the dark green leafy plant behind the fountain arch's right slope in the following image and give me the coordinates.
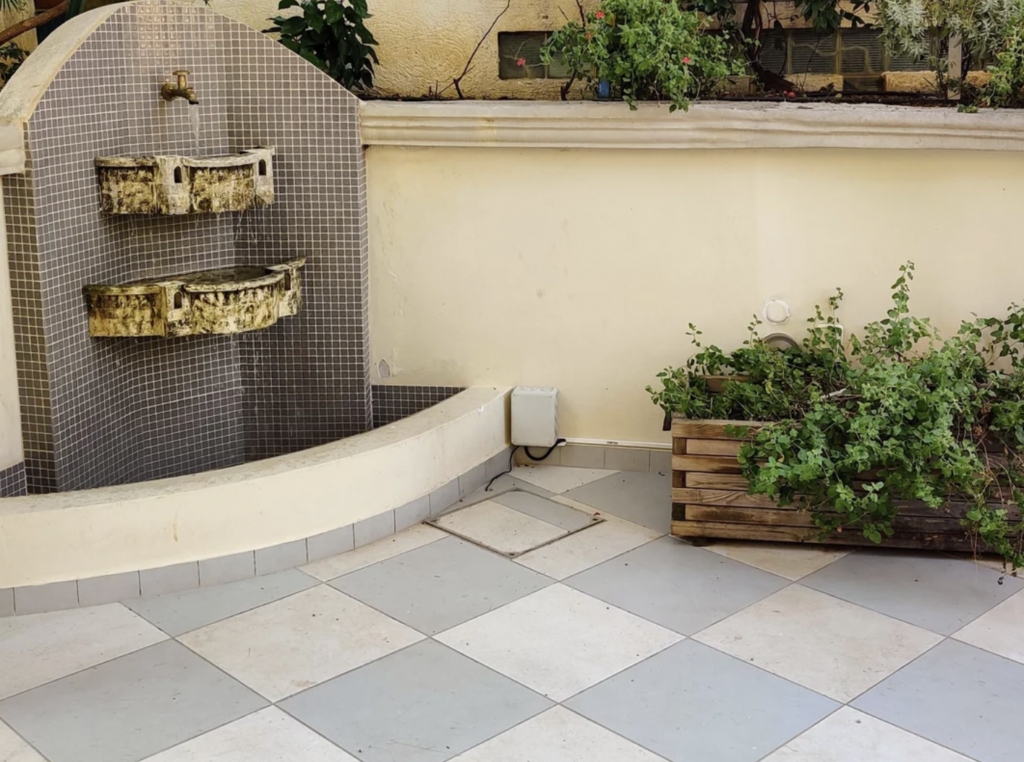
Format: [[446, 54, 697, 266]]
[[266, 0, 380, 90]]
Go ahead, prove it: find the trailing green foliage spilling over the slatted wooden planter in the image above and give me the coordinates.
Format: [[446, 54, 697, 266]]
[[647, 262, 1024, 568]]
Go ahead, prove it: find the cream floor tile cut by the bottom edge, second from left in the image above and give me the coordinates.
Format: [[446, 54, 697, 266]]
[[142, 707, 356, 762]]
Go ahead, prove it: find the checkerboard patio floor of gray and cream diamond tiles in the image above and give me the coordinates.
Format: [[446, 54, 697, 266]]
[[0, 467, 1024, 762]]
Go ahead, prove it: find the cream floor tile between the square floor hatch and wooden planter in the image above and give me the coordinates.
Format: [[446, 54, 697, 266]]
[[515, 515, 659, 580]]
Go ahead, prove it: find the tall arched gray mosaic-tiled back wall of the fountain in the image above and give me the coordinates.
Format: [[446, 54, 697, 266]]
[[4, 0, 373, 492]]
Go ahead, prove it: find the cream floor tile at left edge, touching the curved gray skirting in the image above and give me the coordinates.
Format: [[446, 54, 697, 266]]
[[0, 603, 167, 699]]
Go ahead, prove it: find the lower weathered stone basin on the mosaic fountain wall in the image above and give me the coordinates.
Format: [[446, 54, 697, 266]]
[[83, 258, 306, 338]]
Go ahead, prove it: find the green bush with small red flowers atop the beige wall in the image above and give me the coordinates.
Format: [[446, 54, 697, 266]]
[[541, 0, 742, 111]]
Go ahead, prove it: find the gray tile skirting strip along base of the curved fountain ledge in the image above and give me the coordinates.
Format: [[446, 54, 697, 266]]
[[0, 449, 509, 617]]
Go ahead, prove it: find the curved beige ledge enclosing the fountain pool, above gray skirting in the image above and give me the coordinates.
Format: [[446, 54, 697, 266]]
[[0, 387, 511, 589]]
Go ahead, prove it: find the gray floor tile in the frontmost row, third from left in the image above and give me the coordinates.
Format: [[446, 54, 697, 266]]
[[565, 640, 835, 762]]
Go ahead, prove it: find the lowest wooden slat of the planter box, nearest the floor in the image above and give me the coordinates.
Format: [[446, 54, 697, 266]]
[[672, 521, 985, 552]]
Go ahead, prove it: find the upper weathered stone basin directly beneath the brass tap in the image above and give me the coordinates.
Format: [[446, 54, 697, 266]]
[[96, 149, 274, 214]]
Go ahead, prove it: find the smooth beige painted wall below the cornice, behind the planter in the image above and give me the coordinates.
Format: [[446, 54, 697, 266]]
[[368, 146, 1024, 441]]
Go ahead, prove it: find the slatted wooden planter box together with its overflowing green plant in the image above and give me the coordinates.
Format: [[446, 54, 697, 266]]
[[647, 263, 1024, 568]]
